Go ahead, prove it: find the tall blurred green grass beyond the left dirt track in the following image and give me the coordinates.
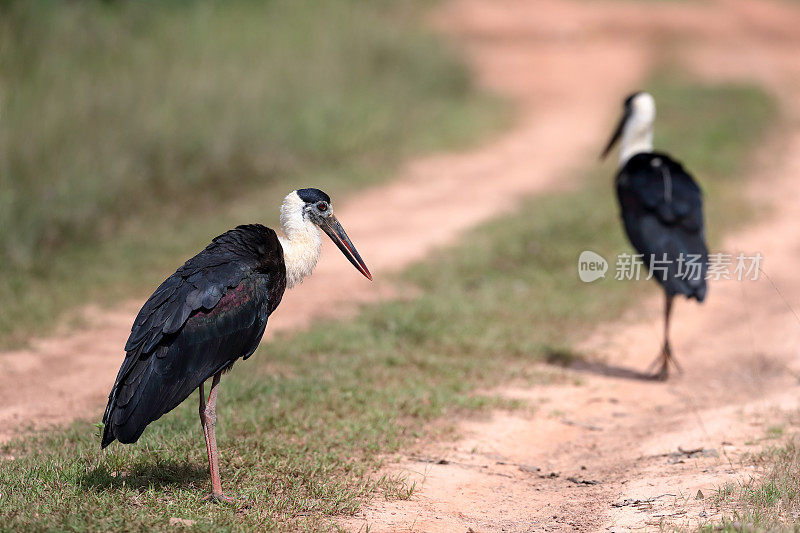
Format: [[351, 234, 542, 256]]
[[0, 0, 505, 344]]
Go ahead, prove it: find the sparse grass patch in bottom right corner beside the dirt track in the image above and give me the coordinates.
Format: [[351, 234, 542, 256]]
[[701, 436, 800, 533]]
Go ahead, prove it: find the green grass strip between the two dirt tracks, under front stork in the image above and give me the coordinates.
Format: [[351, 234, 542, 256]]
[[0, 77, 770, 531]]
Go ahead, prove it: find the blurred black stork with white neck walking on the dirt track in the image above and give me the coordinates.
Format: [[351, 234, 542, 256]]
[[602, 92, 708, 380]]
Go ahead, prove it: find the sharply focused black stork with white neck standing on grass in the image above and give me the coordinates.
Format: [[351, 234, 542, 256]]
[[101, 189, 372, 500]]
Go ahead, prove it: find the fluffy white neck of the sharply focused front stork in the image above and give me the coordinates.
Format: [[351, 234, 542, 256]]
[[278, 192, 322, 289]]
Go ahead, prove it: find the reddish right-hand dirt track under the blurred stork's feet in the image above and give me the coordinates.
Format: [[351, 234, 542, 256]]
[[345, 0, 800, 532]]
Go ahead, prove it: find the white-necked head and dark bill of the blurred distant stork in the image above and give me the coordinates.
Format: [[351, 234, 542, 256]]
[[600, 92, 656, 166]]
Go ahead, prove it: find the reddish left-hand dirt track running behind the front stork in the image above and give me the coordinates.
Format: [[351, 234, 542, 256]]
[[0, 4, 646, 442]]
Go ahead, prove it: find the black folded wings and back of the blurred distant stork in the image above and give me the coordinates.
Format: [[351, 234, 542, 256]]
[[617, 153, 708, 302]]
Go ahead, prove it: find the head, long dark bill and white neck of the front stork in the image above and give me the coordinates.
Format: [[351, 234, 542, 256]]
[[281, 189, 372, 285]]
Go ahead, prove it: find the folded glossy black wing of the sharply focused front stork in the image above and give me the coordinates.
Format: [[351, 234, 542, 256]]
[[102, 225, 286, 447]]
